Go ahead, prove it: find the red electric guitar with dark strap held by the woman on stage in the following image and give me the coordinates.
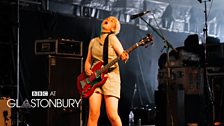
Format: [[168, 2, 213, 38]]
[[77, 34, 153, 98]]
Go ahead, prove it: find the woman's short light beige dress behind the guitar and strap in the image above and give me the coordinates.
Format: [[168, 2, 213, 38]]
[[89, 37, 121, 98]]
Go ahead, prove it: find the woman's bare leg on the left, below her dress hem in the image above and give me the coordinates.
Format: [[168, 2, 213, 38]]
[[87, 93, 102, 126]]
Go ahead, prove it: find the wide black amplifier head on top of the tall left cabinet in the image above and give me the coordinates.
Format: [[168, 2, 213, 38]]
[[35, 39, 82, 56]]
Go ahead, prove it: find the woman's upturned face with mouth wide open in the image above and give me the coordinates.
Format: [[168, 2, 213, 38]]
[[102, 17, 116, 32]]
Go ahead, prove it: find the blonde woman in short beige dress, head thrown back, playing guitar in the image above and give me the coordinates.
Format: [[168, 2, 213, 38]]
[[85, 16, 129, 126]]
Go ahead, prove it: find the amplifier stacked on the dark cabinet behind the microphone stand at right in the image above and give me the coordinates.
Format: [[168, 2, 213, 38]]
[[158, 67, 204, 94]]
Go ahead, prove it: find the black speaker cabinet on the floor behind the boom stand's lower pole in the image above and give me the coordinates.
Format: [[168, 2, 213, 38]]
[[155, 89, 185, 126]]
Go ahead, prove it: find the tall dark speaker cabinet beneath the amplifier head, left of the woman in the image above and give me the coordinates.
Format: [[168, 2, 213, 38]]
[[48, 56, 83, 126]]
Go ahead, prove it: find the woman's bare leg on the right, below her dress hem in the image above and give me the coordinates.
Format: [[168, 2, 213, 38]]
[[104, 96, 122, 126]]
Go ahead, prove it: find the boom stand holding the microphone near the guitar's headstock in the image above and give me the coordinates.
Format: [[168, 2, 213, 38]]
[[140, 17, 177, 126]]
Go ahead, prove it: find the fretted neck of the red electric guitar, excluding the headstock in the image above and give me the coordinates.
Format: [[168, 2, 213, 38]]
[[97, 43, 139, 75]]
